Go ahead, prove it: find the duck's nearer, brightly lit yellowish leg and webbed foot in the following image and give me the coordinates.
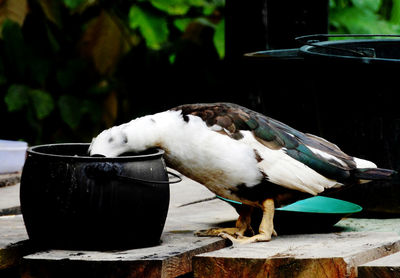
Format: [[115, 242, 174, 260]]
[[221, 199, 277, 243]]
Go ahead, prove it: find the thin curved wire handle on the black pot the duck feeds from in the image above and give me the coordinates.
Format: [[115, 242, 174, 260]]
[[84, 162, 182, 184]]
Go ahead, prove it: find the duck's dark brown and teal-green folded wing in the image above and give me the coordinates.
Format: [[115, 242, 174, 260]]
[[173, 103, 356, 181]]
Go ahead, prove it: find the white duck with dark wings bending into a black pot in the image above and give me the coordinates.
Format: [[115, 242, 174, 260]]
[[89, 102, 397, 243]]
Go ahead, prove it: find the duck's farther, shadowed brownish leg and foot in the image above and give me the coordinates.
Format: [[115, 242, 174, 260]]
[[195, 205, 254, 237]]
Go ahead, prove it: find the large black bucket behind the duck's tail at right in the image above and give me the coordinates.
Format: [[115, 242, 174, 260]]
[[299, 35, 400, 170]]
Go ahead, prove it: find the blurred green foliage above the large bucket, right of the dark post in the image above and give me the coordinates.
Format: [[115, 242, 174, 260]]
[[329, 0, 400, 34]]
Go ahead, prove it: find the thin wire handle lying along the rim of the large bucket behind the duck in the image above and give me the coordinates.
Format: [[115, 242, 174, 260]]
[[295, 34, 400, 58]]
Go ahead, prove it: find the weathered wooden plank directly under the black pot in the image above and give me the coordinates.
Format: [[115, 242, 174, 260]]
[[23, 232, 227, 278]]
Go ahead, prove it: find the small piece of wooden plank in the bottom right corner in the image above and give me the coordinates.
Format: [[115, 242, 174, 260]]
[[358, 252, 400, 278]]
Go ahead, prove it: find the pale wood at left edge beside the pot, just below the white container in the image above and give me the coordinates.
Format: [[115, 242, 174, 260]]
[[0, 183, 21, 216]]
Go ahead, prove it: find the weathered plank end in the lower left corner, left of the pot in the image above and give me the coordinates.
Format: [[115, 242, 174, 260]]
[[0, 215, 29, 270]]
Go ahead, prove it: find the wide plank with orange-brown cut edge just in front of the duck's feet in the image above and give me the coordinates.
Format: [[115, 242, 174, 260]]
[[193, 232, 400, 278]]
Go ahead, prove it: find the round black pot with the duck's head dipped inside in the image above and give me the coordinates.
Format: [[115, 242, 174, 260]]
[[20, 144, 169, 250]]
